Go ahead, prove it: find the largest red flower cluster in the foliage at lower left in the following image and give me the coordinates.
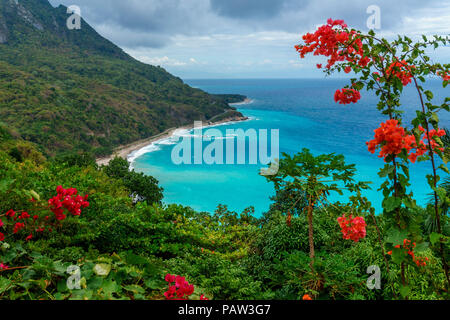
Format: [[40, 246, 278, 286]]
[[48, 186, 89, 220]]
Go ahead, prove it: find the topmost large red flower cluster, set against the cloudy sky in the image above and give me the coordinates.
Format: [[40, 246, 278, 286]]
[[295, 19, 370, 73]]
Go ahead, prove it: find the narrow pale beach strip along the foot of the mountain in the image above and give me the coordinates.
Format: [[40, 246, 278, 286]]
[[96, 104, 253, 166]]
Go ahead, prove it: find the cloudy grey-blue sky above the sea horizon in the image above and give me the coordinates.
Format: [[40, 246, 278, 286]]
[[50, 0, 450, 79]]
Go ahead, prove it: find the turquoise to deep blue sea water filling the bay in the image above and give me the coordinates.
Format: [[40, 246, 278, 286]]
[[133, 79, 450, 216]]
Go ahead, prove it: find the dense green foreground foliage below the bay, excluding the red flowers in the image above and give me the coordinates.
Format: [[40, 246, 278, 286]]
[[0, 124, 448, 299]]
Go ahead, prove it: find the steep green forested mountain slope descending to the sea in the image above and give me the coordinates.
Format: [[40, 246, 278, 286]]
[[0, 0, 241, 155]]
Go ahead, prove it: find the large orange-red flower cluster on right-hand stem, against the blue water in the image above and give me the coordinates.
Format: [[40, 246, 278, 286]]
[[366, 119, 416, 160]]
